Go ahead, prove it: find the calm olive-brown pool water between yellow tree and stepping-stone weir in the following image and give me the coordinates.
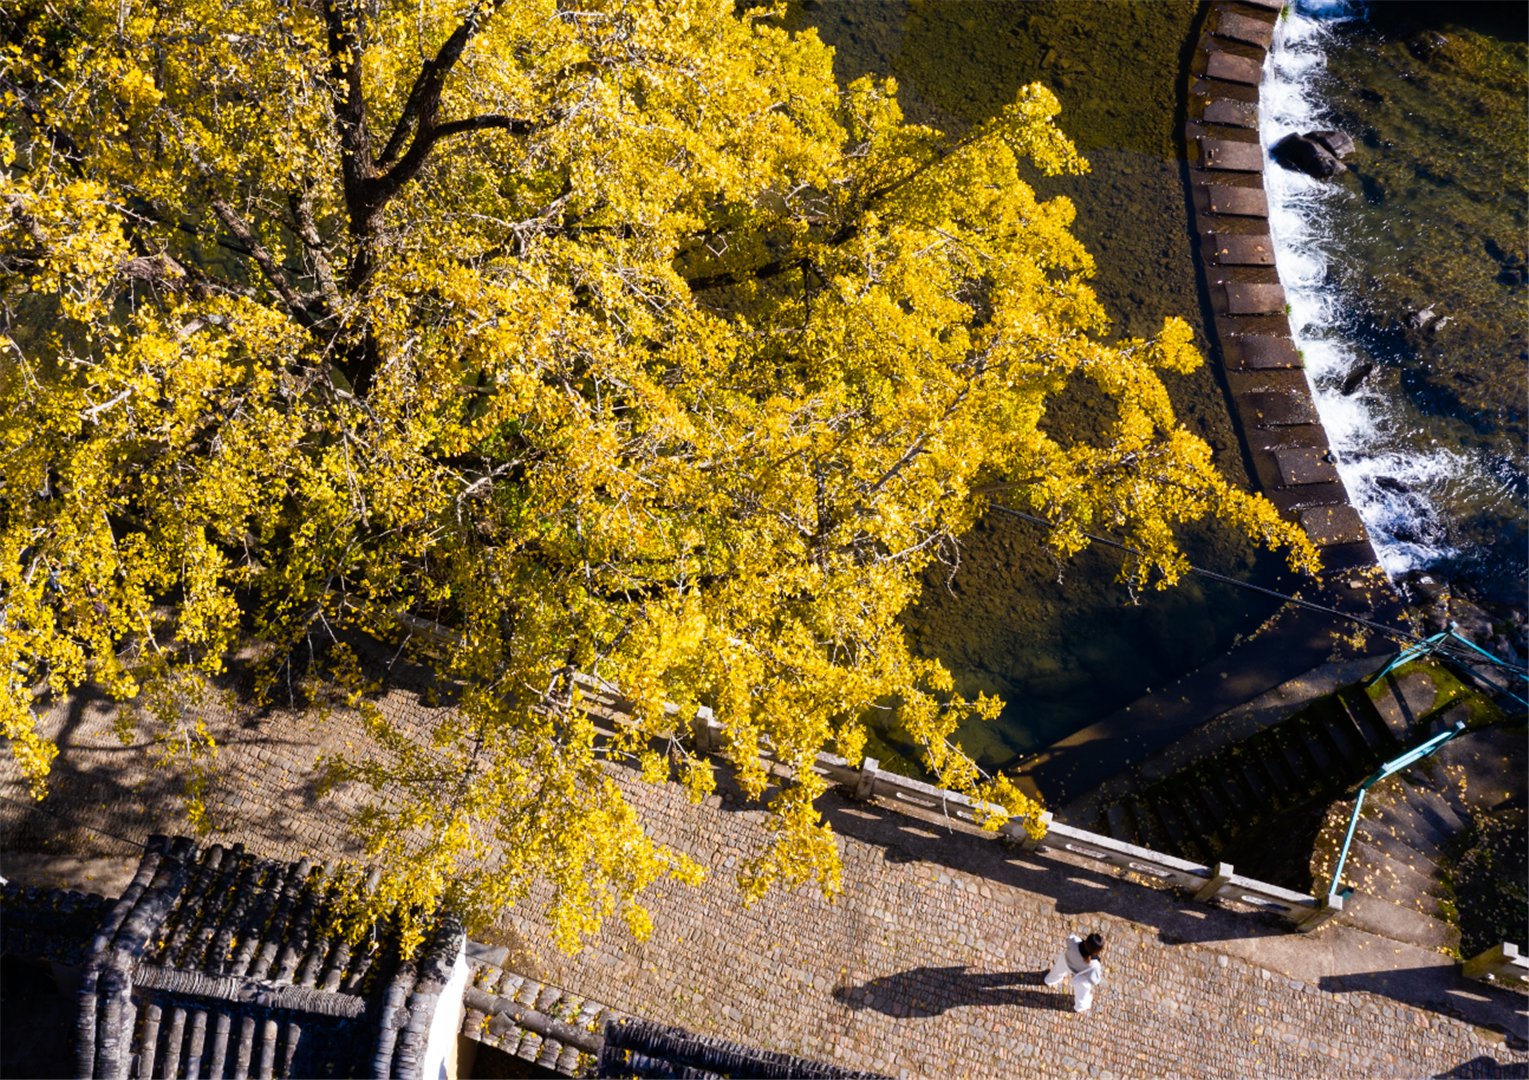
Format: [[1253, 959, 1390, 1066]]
[[787, 0, 1272, 766]]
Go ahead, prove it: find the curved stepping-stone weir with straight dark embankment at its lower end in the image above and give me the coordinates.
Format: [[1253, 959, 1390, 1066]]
[[1017, 0, 1399, 807]]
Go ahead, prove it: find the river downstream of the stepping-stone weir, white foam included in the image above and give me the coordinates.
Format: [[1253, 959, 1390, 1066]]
[[1260, 0, 1529, 607]]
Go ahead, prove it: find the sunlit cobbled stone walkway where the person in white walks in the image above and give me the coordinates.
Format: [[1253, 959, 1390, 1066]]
[[0, 693, 1529, 1077]]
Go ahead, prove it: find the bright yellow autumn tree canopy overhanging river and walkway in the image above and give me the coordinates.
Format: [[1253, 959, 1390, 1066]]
[[0, 0, 1313, 945]]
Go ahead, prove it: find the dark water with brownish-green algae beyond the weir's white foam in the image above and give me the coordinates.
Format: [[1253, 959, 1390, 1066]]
[[1290, 3, 1529, 606]]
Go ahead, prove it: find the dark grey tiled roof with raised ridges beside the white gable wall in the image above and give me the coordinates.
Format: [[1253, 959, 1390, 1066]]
[[75, 837, 463, 1077]]
